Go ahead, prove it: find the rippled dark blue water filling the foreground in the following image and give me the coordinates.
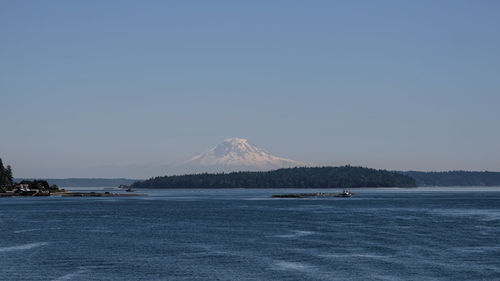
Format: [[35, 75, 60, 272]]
[[0, 188, 500, 280]]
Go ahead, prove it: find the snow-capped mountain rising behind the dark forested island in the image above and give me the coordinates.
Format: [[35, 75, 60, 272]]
[[178, 138, 306, 172]]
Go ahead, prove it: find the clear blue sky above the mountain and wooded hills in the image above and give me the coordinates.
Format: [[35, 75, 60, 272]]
[[0, 0, 500, 177]]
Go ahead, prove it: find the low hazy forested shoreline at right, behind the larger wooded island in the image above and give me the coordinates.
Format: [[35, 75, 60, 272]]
[[399, 171, 500, 186]]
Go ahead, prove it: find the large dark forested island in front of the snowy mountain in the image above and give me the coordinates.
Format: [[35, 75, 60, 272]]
[[131, 166, 417, 188]]
